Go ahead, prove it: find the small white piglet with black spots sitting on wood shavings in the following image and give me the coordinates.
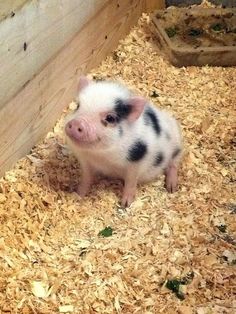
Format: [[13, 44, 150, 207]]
[[65, 77, 182, 207]]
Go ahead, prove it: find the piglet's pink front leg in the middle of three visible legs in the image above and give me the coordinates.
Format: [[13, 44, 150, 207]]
[[121, 167, 138, 207]]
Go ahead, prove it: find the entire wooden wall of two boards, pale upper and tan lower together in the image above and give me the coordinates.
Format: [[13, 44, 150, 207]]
[[0, 0, 164, 175]]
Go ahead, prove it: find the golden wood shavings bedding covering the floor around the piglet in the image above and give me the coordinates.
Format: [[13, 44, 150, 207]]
[[0, 11, 236, 314]]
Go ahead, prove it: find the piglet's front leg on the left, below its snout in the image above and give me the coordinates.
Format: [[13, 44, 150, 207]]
[[77, 162, 94, 197]]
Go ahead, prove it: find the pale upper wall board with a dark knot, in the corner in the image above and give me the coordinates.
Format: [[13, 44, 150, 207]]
[[0, 0, 108, 108]]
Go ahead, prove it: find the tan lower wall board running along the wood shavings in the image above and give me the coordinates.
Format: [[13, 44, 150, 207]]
[[0, 0, 165, 175]]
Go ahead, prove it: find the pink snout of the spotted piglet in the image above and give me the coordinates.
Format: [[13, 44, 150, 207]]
[[65, 119, 97, 142]]
